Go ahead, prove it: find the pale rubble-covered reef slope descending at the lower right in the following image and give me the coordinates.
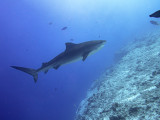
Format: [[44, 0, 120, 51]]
[[75, 30, 160, 120]]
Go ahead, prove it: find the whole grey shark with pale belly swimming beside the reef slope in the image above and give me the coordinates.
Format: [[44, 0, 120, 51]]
[[11, 40, 106, 82]]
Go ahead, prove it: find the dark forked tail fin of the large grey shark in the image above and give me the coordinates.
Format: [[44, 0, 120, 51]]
[[11, 66, 38, 83]]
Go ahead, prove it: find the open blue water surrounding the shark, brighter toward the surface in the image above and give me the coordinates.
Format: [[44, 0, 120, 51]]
[[0, 0, 160, 120]]
